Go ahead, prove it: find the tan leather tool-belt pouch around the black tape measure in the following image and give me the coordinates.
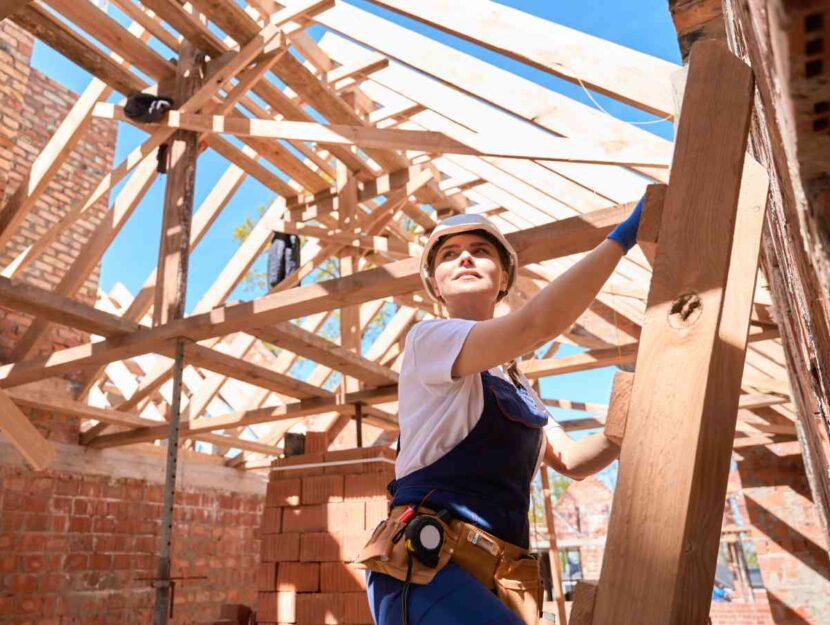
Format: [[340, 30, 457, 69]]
[[353, 510, 458, 585]]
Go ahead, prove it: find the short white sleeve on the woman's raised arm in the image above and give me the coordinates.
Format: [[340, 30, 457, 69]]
[[405, 319, 476, 385]]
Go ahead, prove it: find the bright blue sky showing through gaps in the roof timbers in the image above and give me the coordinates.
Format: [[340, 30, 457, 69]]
[[32, 0, 680, 464]]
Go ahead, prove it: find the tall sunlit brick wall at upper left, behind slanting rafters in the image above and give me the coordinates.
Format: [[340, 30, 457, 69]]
[[0, 20, 115, 361]]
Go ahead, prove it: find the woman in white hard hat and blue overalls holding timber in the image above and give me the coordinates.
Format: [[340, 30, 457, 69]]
[[357, 201, 642, 625]]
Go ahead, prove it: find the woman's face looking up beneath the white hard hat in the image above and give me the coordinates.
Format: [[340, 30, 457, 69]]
[[432, 232, 507, 308]]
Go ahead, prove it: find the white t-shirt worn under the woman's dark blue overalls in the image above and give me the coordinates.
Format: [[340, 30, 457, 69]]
[[395, 319, 558, 479]]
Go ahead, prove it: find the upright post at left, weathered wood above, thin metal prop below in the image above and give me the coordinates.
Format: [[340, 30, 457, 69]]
[[153, 39, 203, 625]]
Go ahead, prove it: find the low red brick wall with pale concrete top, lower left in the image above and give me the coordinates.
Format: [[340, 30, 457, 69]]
[[0, 442, 265, 625]]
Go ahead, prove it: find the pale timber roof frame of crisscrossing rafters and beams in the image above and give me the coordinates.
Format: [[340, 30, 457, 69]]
[[0, 0, 830, 613]]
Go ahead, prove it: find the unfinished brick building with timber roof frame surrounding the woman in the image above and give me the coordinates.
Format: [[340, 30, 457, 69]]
[[0, 0, 830, 625]]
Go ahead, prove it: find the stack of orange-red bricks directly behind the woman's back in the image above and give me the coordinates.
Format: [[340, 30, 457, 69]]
[[257, 446, 394, 625]]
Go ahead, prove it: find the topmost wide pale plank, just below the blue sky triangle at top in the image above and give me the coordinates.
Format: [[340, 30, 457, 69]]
[[372, 0, 681, 117]]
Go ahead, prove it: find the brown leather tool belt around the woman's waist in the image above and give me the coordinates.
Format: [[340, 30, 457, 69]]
[[354, 506, 542, 625]]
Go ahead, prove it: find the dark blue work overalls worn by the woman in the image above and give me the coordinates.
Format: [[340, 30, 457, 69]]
[[366, 372, 548, 625]]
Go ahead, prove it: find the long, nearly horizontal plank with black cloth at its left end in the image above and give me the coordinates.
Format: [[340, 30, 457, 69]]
[[93, 103, 669, 168]]
